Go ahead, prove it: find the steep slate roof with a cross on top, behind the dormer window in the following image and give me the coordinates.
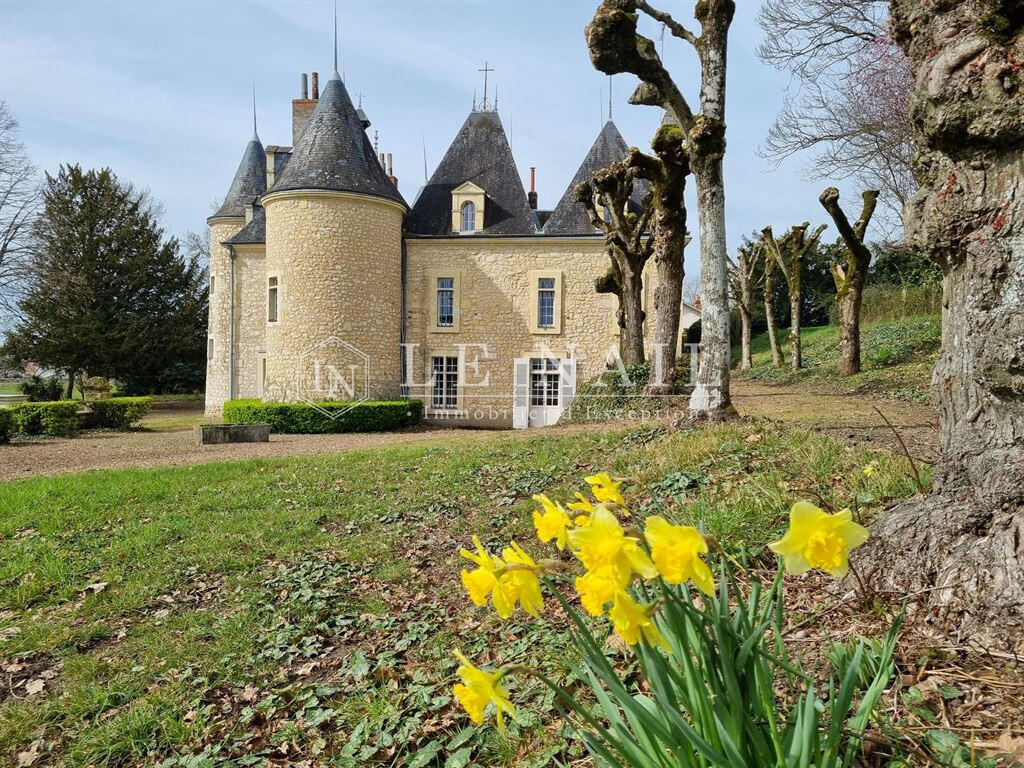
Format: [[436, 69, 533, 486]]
[[407, 110, 537, 234]]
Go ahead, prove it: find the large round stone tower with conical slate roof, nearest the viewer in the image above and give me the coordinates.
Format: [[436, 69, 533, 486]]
[[263, 71, 408, 400]]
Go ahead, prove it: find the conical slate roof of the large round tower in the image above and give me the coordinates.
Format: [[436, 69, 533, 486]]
[[270, 77, 406, 206]]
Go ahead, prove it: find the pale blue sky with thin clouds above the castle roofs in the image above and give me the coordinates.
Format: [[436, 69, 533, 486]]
[[0, 0, 850, 276]]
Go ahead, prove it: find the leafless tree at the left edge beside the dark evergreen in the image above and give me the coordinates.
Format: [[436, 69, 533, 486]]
[[0, 101, 41, 315]]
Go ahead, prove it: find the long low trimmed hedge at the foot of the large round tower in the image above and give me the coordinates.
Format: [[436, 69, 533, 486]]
[[224, 399, 423, 434]]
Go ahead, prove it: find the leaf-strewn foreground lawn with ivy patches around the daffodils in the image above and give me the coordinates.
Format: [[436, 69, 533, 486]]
[[0, 423, 929, 766]]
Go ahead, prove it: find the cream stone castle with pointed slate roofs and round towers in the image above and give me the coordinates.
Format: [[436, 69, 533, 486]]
[[206, 61, 698, 427]]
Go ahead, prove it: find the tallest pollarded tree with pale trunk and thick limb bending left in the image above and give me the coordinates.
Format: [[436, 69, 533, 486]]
[[586, 0, 735, 417]]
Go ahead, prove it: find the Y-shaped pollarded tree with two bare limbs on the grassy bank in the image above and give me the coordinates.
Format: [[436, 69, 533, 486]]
[[819, 186, 879, 376]]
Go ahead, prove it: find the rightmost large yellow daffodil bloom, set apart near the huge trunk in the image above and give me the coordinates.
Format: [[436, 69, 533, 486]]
[[768, 502, 867, 579]]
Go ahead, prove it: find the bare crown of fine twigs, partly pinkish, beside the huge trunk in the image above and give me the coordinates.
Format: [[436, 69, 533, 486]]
[[758, 0, 918, 234]]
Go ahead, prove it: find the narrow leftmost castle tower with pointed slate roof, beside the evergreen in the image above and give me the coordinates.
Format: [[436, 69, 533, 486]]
[[206, 126, 266, 416]]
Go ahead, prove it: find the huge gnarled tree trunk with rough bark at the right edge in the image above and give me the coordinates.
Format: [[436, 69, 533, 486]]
[[865, 0, 1024, 649]]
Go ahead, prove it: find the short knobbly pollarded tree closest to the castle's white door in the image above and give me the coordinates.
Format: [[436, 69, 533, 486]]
[[575, 162, 653, 366]]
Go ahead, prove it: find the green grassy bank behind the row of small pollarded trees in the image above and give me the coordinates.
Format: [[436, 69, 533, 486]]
[[734, 315, 942, 402]]
